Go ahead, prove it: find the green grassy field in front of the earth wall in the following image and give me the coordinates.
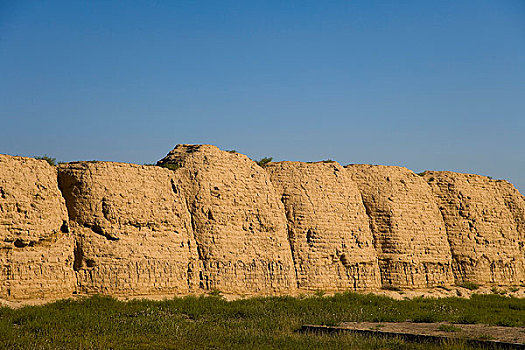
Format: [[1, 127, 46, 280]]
[[0, 293, 525, 349]]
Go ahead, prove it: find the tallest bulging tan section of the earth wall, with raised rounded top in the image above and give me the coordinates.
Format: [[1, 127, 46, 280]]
[[158, 145, 297, 294]]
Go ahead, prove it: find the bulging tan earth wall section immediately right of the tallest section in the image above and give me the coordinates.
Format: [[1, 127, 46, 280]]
[[265, 162, 380, 291]]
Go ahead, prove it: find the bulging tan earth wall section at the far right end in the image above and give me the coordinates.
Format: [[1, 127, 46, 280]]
[[424, 171, 524, 285]]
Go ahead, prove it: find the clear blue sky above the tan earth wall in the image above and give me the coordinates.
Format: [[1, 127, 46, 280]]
[[0, 0, 525, 193]]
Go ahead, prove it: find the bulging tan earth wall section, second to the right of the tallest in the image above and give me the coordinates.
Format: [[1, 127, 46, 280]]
[[346, 164, 454, 288]]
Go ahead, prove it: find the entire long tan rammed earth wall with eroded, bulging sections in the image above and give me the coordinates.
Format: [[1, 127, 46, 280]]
[[0, 145, 525, 301]]
